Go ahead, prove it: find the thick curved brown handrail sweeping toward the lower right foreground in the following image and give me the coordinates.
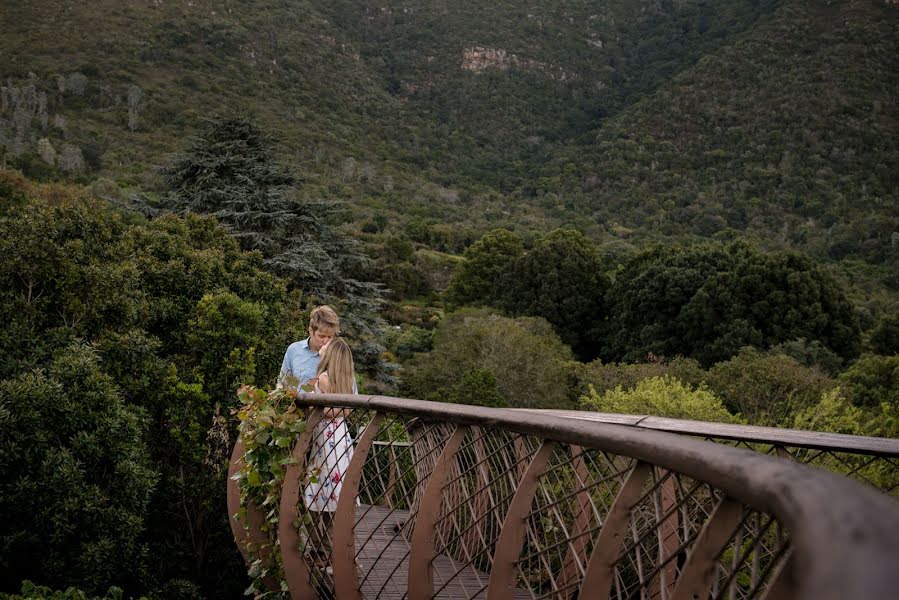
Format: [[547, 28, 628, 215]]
[[297, 394, 899, 599]]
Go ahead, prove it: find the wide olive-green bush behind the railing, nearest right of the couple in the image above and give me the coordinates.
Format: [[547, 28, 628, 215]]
[[402, 310, 571, 408]]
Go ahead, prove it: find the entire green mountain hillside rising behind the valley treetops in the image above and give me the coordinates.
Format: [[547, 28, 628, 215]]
[[0, 0, 899, 276]]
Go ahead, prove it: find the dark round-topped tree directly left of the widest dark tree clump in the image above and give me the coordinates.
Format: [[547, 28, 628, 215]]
[[503, 229, 609, 358]]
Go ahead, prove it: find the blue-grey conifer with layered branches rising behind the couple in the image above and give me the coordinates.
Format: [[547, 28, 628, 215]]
[[163, 115, 382, 330]]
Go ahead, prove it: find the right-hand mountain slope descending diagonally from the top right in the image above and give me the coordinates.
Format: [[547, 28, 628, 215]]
[[557, 2, 899, 265]]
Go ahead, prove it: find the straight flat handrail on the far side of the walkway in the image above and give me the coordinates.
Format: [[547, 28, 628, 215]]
[[511, 408, 899, 457]]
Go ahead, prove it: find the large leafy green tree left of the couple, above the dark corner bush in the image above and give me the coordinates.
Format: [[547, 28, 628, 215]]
[[0, 199, 306, 597]]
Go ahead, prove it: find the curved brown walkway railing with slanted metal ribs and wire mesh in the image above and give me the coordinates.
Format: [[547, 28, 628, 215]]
[[228, 394, 899, 600]]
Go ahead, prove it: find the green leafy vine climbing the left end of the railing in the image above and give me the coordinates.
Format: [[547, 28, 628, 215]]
[[232, 386, 306, 598]]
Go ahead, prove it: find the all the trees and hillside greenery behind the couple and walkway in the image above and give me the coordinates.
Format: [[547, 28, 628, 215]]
[[0, 0, 899, 600]]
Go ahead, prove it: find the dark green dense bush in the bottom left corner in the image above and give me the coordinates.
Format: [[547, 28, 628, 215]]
[[0, 345, 158, 593]]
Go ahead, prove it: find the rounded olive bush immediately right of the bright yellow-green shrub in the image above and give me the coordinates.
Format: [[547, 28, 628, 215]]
[[706, 348, 836, 427]]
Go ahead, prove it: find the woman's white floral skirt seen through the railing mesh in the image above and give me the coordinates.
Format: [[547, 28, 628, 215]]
[[303, 383, 353, 512]]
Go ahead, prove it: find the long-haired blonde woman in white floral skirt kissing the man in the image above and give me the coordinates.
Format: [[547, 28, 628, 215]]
[[303, 338, 357, 566]]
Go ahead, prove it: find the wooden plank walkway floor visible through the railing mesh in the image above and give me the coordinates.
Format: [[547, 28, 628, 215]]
[[319, 504, 532, 600]]
